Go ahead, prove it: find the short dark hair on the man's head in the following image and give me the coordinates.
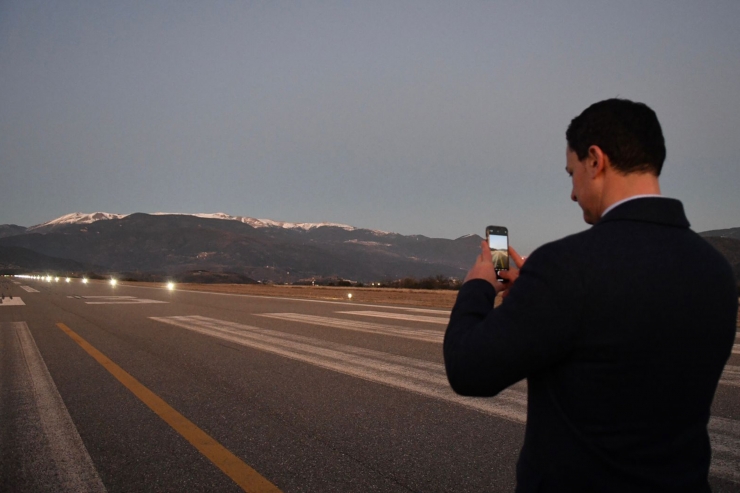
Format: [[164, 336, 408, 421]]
[[565, 99, 665, 176]]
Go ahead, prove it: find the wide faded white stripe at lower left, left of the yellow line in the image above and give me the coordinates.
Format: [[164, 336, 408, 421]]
[[0, 322, 106, 492]]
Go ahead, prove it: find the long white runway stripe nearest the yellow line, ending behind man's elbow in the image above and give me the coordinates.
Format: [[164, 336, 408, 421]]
[[150, 316, 527, 423]]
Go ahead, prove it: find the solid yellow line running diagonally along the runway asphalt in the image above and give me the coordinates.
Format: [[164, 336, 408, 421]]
[[57, 323, 280, 493]]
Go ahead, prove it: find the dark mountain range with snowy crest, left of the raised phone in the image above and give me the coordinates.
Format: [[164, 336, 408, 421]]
[[0, 212, 481, 282]]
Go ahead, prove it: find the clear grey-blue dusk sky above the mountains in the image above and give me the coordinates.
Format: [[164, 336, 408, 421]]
[[0, 0, 740, 254]]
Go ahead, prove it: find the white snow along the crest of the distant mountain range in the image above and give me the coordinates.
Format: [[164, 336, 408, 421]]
[[26, 212, 391, 235]]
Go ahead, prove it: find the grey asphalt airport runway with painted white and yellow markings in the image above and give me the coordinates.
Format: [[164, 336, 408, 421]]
[[0, 278, 740, 493]]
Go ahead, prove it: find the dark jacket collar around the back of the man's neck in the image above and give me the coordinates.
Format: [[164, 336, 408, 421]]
[[596, 197, 690, 228]]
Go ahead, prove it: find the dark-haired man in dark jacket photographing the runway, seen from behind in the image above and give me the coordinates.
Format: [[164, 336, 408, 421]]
[[444, 99, 737, 492]]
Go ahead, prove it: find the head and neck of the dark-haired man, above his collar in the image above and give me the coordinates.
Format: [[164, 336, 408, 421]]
[[565, 99, 666, 224]]
